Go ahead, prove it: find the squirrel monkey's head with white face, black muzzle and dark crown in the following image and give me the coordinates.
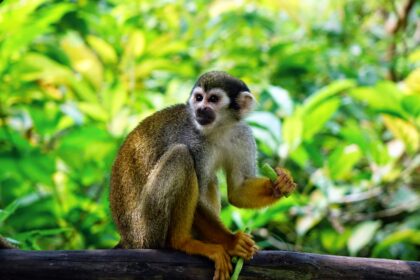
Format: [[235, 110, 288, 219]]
[[188, 71, 255, 129]]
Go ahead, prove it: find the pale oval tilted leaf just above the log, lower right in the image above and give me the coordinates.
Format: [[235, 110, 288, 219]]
[[347, 221, 381, 256]]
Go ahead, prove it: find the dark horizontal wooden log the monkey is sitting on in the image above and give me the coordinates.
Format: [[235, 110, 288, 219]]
[[0, 250, 420, 280]]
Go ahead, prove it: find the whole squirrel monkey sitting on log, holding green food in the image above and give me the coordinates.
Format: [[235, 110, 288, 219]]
[[110, 71, 296, 280]]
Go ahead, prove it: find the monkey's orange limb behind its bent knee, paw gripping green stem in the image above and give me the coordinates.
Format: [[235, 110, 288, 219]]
[[194, 202, 257, 260]]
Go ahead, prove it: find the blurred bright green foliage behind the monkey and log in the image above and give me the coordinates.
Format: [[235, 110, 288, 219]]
[[0, 0, 420, 260]]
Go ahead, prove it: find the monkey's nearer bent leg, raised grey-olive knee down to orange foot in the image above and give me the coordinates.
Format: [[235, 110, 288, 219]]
[[143, 145, 232, 280]]
